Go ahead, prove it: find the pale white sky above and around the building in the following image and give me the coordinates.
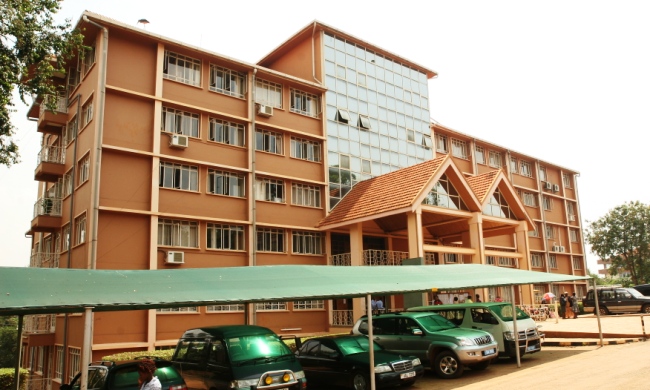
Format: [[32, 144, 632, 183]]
[[0, 0, 650, 272]]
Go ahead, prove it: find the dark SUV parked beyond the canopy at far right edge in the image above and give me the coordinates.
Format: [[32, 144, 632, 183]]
[[582, 287, 650, 315]]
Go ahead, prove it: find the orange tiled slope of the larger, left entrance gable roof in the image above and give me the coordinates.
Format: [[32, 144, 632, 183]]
[[318, 155, 448, 227]]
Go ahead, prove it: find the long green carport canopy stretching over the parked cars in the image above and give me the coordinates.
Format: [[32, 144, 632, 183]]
[[0, 264, 590, 315]]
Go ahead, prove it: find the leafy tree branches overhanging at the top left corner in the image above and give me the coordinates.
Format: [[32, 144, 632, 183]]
[[0, 0, 82, 166]]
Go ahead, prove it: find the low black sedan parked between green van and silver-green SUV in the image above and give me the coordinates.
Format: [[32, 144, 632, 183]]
[[296, 335, 424, 390]]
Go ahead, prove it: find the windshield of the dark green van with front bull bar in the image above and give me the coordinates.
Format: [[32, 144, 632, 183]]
[[226, 334, 293, 362]]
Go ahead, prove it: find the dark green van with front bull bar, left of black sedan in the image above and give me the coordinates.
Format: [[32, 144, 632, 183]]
[[172, 325, 307, 390]]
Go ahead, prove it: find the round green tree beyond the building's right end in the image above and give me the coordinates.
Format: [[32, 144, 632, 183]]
[[585, 201, 650, 285]]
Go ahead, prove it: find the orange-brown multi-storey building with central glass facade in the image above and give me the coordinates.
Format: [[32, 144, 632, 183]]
[[23, 12, 585, 387]]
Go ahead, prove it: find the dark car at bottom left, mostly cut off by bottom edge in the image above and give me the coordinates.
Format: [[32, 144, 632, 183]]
[[60, 359, 187, 390]]
